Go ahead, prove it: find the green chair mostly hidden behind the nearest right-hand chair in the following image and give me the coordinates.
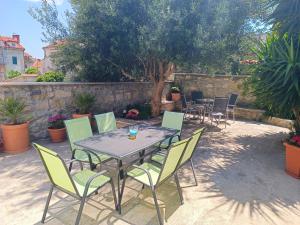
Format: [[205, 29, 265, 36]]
[[151, 128, 205, 186]]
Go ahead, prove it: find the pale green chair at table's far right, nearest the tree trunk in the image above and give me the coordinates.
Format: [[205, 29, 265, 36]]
[[157, 111, 184, 149]]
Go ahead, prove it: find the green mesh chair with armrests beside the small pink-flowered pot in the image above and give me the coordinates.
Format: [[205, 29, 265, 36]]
[[64, 117, 111, 171]]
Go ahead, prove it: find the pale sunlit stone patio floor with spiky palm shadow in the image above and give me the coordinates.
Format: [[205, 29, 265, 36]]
[[0, 118, 300, 225]]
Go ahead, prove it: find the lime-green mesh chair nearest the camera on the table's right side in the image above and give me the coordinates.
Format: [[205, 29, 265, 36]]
[[119, 138, 190, 225]]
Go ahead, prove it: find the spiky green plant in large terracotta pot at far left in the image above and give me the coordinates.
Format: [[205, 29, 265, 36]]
[[0, 97, 29, 153]]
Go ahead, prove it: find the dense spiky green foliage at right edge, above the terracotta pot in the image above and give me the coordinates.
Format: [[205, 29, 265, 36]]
[[246, 35, 300, 129]]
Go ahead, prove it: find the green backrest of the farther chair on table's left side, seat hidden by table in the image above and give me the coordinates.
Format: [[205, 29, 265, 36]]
[[95, 112, 117, 134]]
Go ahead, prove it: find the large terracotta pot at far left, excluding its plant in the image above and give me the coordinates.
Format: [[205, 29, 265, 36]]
[[1, 122, 29, 154]]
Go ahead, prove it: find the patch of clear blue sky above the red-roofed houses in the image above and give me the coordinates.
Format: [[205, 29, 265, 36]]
[[0, 0, 70, 58]]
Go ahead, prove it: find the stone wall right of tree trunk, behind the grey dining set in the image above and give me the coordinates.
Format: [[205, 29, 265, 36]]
[[174, 73, 254, 105]]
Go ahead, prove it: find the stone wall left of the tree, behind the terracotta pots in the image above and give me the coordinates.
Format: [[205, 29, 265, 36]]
[[0, 82, 152, 139]]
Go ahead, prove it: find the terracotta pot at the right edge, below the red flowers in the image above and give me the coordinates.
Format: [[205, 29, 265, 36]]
[[284, 143, 300, 179]]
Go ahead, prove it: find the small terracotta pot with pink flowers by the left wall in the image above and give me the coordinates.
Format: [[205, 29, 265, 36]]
[[48, 114, 67, 143]]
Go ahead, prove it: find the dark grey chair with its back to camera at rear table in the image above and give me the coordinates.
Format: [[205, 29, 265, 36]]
[[209, 97, 228, 128]]
